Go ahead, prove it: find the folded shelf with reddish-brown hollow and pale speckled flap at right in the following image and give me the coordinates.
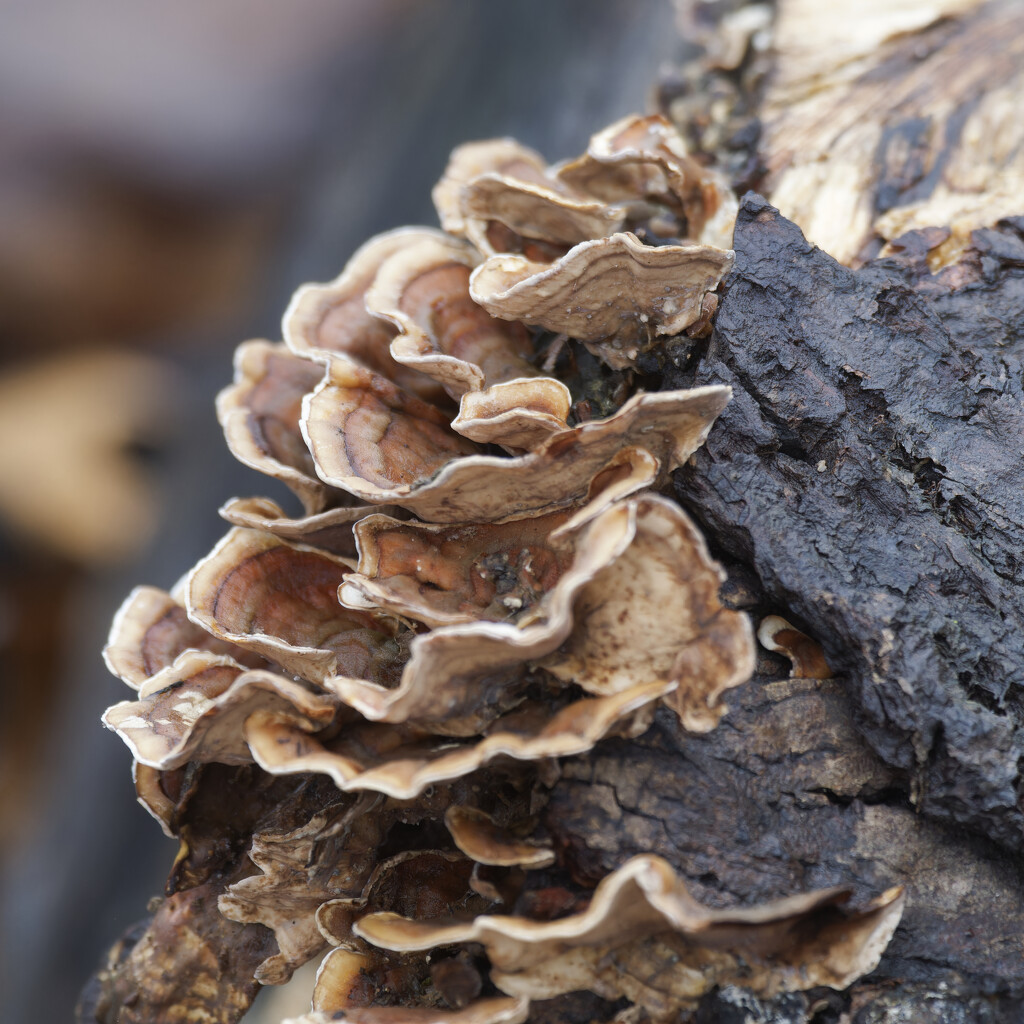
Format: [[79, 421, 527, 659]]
[[330, 496, 754, 729]]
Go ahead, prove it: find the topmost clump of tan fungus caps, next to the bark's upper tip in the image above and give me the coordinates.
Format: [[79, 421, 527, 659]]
[[435, 116, 737, 369]]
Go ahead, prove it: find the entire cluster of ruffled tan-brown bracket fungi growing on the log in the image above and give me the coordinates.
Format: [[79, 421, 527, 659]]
[[94, 117, 902, 1024]]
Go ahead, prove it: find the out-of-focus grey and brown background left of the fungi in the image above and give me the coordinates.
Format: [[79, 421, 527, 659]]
[[0, 0, 684, 1024]]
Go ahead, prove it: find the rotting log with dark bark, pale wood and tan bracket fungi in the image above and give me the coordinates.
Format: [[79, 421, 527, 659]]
[[78, 0, 1024, 1024]]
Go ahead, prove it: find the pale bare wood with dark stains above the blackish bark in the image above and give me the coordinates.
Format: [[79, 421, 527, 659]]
[[760, 0, 1024, 268]]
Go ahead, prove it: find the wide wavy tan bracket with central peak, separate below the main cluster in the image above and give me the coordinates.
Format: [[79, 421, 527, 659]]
[[354, 856, 903, 1020]]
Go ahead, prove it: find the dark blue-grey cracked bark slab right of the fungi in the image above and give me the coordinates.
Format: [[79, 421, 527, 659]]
[[678, 196, 1024, 849]]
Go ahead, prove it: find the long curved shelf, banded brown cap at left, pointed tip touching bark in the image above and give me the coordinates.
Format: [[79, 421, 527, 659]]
[[302, 380, 731, 522]]
